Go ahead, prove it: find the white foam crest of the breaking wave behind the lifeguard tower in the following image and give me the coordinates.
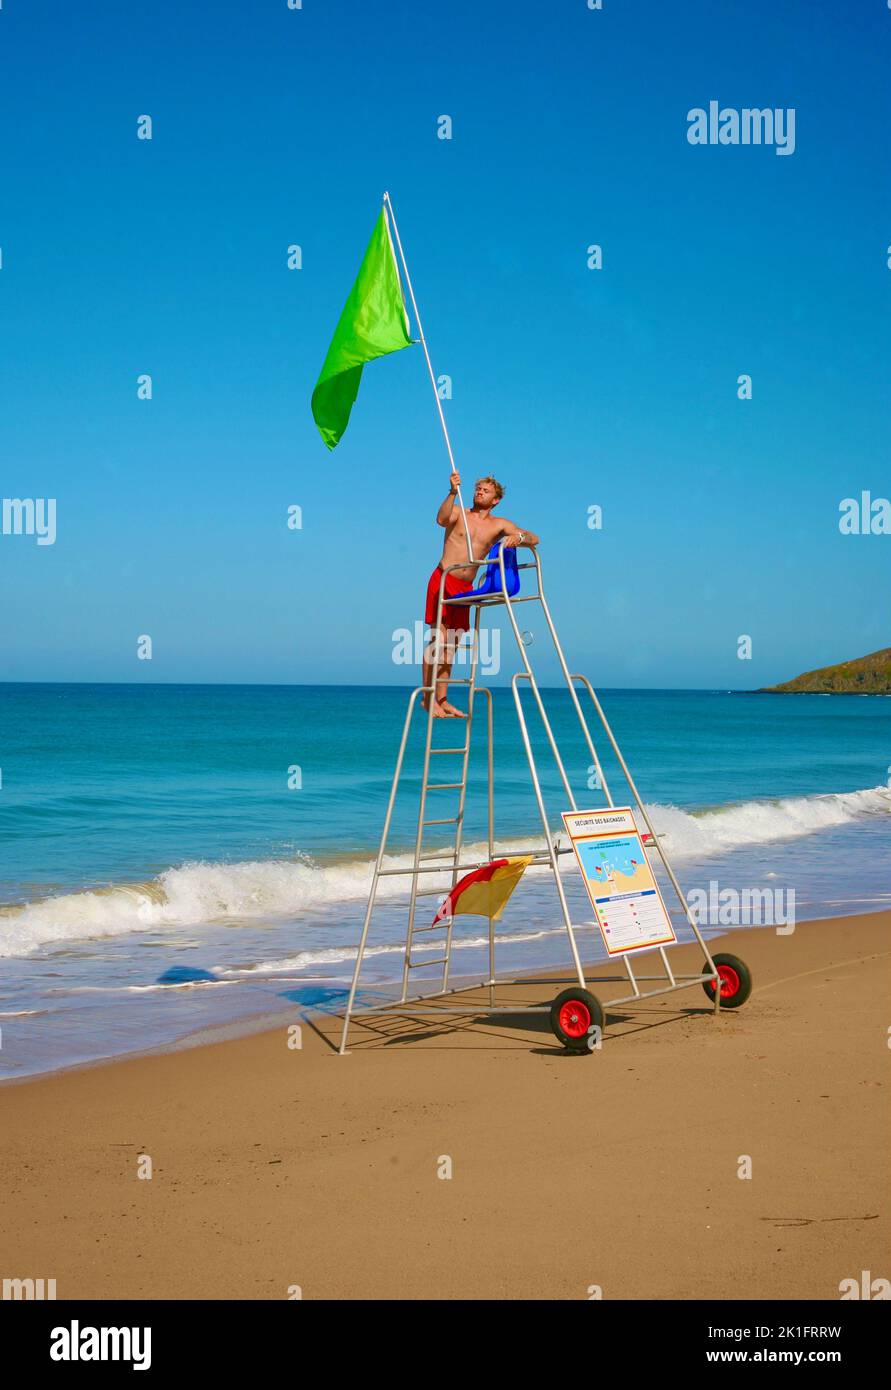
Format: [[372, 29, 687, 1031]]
[[0, 787, 891, 969]]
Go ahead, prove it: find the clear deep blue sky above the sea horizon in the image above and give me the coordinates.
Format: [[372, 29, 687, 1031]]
[[0, 0, 891, 688]]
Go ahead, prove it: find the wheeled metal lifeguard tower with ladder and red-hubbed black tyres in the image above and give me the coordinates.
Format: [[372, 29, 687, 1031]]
[[339, 541, 752, 1054]]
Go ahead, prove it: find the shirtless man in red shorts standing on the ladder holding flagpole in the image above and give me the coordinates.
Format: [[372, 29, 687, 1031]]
[[423, 471, 538, 719]]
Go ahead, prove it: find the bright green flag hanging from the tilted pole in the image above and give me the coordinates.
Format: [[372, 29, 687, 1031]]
[[313, 209, 411, 449]]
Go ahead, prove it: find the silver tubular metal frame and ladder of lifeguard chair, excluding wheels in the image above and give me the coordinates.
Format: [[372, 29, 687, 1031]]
[[339, 541, 742, 1055]]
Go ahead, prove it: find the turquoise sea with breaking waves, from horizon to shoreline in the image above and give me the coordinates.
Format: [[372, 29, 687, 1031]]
[[0, 684, 891, 1079]]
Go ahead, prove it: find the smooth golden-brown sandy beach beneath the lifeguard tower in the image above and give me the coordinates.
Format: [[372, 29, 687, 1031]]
[[0, 912, 891, 1300]]
